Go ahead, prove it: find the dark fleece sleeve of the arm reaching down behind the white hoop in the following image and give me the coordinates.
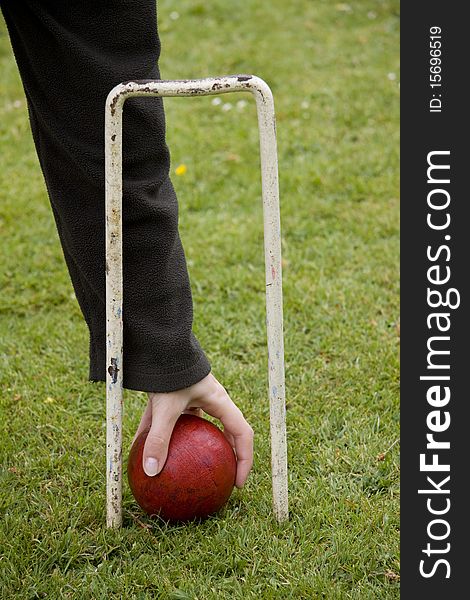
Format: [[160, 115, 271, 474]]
[[0, 0, 210, 392]]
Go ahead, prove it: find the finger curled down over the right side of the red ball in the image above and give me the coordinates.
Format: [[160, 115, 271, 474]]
[[200, 388, 254, 488]]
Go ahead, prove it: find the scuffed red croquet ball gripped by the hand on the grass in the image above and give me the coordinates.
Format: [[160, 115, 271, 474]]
[[127, 414, 237, 521]]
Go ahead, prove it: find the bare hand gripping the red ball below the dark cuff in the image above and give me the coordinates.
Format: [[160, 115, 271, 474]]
[[132, 373, 253, 488]]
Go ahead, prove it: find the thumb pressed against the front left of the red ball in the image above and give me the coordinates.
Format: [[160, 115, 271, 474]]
[[142, 399, 182, 477]]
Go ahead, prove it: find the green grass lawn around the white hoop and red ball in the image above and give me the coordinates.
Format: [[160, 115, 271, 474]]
[[0, 0, 399, 600]]
